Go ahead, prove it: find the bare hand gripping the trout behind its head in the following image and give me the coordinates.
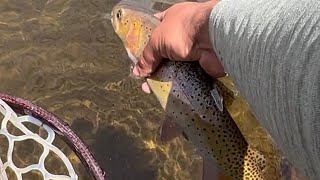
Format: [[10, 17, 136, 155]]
[[133, 0, 225, 91]]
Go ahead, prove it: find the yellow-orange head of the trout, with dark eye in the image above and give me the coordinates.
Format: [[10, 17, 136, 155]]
[[111, 5, 159, 63]]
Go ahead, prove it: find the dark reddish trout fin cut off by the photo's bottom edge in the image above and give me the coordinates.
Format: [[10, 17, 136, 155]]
[[202, 159, 232, 180]]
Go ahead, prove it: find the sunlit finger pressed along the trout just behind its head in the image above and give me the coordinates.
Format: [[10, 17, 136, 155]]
[[133, 25, 162, 77]]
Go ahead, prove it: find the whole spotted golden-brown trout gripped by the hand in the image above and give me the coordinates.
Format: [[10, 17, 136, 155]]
[[111, 4, 266, 179]]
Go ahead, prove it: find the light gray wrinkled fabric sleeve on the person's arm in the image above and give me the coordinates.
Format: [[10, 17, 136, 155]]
[[209, 0, 320, 179]]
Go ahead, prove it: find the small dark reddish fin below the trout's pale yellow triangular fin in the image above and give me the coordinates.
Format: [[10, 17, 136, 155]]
[[160, 117, 183, 142]]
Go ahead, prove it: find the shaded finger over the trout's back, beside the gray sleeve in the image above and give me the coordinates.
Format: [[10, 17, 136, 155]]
[[199, 50, 225, 78]]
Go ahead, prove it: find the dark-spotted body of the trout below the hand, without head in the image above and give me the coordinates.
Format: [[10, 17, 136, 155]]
[[147, 61, 264, 179]]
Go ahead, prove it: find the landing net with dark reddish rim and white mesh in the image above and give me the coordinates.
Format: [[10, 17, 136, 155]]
[[0, 94, 106, 180]]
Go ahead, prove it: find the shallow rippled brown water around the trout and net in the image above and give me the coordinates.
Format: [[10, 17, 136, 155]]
[[0, 0, 302, 180]]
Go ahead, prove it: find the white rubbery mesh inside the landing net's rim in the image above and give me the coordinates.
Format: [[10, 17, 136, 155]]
[[0, 99, 78, 180]]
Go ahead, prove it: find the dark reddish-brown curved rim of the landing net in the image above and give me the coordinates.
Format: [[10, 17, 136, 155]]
[[0, 93, 107, 180]]
